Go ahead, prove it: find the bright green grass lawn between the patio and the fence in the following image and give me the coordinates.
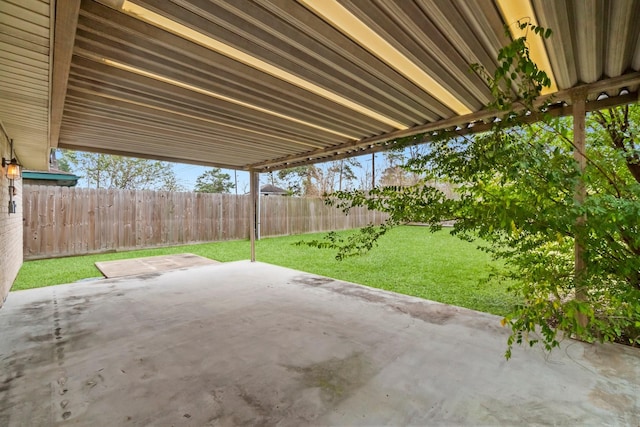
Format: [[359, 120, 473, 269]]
[[13, 226, 516, 315]]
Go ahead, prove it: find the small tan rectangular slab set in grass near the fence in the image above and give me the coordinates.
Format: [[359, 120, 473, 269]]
[[95, 253, 220, 278]]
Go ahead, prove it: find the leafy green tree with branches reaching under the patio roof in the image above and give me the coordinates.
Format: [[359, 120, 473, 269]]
[[304, 23, 640, 358]]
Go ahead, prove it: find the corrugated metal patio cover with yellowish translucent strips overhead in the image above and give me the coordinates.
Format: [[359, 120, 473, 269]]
[[0, 0, 640, 170]]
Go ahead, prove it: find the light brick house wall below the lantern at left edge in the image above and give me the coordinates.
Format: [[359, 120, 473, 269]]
[[0, 133, 22, 307]]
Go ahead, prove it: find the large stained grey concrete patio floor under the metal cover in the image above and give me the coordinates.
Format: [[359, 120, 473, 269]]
[[0, 262, 640, 427]]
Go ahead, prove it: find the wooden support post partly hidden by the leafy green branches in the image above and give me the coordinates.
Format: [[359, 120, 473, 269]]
[[571, 89, 587, 327]]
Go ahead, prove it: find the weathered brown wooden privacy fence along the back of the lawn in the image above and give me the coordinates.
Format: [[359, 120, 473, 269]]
[[22, 185, 386, 259]]
